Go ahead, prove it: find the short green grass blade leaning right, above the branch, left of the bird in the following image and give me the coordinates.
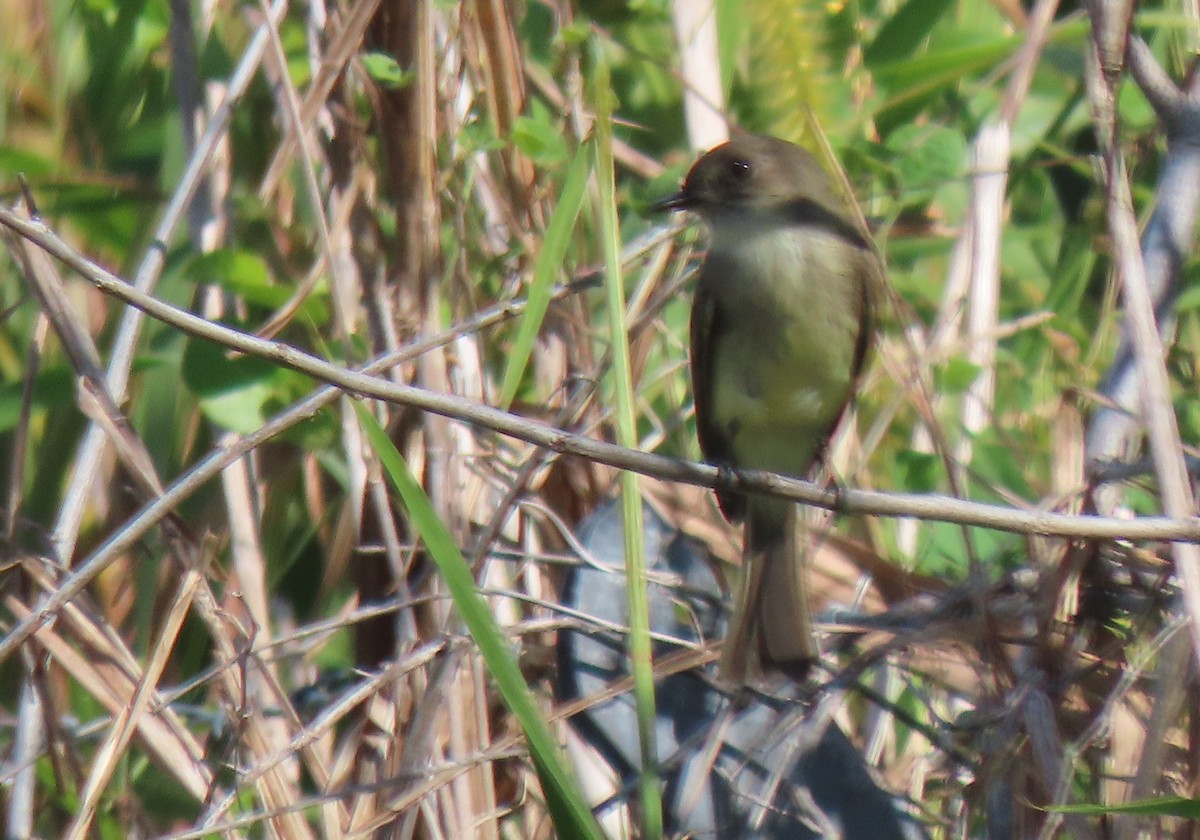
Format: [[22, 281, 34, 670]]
[[500, 143, 590, 408]]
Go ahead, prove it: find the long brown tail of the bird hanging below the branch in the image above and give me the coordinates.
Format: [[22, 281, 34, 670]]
[[721, 503, 820, 685]]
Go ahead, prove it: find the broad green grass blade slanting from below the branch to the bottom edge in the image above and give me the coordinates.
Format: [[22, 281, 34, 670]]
[[354, 403, 604, 840]]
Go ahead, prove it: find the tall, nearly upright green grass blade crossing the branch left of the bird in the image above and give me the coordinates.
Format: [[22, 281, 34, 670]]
[[592, 42, 662, 840]]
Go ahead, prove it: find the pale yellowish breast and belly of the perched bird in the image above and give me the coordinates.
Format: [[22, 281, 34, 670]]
[[702, 227, 864, 474]]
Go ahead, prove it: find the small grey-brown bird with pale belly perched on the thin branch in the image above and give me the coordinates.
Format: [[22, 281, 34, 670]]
[[655, 134, 883, 685]]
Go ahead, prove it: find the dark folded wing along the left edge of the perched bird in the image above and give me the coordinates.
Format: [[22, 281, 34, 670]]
[[691, 252, 746, 522]]
